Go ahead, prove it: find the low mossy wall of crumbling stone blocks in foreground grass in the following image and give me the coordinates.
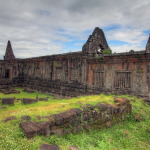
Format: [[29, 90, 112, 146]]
[[20, 100, 132, 138]]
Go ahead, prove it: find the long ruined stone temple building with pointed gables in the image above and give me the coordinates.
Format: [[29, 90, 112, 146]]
[[0, 27, 150, 97]]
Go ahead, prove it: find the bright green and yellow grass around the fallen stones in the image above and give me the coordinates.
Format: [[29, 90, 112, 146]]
[[0, 89, 150, 150]]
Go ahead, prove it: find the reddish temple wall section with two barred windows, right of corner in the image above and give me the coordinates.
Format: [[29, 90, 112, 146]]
[[88, 53, 150, 96]]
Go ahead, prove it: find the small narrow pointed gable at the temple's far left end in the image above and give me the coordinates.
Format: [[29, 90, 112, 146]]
[[4, 41, 15, 60]]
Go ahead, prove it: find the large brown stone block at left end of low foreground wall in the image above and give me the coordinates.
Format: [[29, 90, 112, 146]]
[[20, 121, 50, 138]]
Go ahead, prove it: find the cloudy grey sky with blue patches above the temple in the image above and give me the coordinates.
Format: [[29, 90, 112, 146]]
[[0, 0, 150, 59]]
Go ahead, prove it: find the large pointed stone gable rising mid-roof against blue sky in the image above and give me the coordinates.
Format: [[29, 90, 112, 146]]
[[82, 27, 110, 54]]
